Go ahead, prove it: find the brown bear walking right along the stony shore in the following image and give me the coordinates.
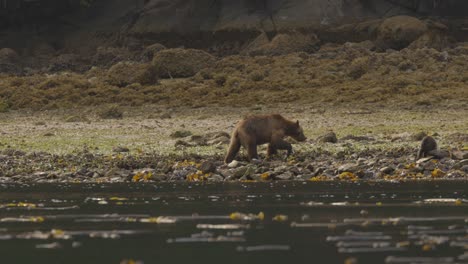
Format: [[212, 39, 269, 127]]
[[224, 114, 306, 163]]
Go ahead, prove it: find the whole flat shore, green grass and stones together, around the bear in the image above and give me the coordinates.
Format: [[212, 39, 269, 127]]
[[0, 104, 468, 183]]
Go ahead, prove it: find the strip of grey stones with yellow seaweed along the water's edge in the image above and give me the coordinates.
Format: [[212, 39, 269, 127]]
[[0, 132, 468, 183]]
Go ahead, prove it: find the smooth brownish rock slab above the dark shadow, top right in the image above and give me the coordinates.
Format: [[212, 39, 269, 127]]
[[131, 0, 468, 33]]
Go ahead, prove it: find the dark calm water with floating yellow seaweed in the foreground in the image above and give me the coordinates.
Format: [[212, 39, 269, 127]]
[[0, 182, 468, 264]]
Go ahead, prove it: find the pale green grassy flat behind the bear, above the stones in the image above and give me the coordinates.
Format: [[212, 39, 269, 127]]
[[0, 105, 468, 155]]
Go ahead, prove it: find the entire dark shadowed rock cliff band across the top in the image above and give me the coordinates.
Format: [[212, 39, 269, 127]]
[[0, 0, 468, 54]]
